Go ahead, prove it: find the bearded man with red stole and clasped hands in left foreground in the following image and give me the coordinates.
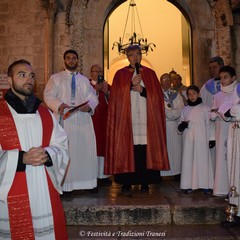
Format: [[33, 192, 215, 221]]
[[0, 59, 69, 240]]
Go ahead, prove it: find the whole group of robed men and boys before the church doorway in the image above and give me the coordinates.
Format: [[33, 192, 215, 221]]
[[0, 50, 240, 240]]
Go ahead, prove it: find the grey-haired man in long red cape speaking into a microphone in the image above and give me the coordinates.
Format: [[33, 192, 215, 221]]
[[105, 45, 169, 194]]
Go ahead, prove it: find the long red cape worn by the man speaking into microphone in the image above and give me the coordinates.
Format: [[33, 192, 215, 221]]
[[105, 66, 170, 174]]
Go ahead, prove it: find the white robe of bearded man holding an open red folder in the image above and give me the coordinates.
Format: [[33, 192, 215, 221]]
[[44, 70, 98, 191]]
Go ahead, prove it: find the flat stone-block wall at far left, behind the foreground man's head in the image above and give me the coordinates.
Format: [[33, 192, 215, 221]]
[[0, 0, 45, 95]]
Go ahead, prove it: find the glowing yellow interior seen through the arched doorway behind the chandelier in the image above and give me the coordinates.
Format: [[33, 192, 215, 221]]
[[104, 0, 192, 85]]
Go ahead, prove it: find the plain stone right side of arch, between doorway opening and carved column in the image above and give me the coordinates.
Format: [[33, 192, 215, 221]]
[[167, 0, 217, 87]]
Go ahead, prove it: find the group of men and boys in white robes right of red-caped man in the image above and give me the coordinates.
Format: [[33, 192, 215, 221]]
[[160, 59, 240, 225]]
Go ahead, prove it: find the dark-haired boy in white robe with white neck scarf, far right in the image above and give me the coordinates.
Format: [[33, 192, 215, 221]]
[[211, 66, 239, 196]]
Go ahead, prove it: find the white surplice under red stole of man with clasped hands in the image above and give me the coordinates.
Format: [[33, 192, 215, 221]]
[[0, 106, 69, 240]]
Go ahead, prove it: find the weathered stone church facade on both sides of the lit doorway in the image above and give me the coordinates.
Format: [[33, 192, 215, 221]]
[[0, 0, 240, 98]]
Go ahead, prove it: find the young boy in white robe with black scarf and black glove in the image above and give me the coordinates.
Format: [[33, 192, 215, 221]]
[[178, 85, 213, 194]]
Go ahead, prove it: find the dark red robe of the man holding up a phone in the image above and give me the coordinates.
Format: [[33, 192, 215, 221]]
[[91, 80, 110, 157]]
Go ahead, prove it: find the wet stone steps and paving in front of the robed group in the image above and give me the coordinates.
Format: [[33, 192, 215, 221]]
[[61, 178, 240, 240]]
